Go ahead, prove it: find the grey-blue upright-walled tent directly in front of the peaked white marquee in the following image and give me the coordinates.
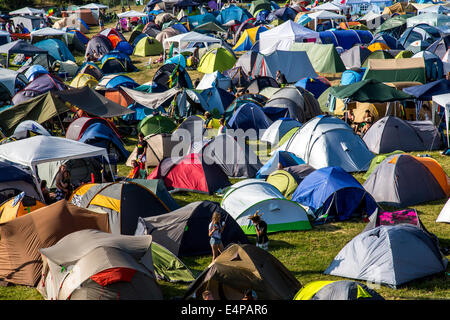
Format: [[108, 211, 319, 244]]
[[252, 49, 317, 83]]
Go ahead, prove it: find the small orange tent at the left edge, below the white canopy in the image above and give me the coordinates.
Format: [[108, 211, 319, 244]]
[[0, 192, 46, 223]]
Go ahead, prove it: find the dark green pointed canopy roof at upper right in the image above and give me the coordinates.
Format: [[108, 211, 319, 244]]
[[330, 79, 414, 103]]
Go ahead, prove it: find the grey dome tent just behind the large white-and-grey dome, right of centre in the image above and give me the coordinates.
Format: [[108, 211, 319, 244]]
[[264, 87, 322, 123]]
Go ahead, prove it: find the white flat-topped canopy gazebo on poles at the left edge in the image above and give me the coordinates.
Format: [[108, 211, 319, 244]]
[[0, 136, 112, 198]]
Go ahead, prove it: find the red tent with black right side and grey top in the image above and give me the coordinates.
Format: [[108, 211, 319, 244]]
[[148, 153, 230, 194]]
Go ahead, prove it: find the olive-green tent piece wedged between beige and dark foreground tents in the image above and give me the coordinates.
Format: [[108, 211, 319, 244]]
[[152, 241, 195, 282]]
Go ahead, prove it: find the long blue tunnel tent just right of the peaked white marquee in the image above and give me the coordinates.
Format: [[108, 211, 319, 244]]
[[319, 30, 373, 50]]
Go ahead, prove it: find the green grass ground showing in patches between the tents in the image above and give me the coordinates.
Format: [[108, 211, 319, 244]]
[[0, 6, 450, 300]]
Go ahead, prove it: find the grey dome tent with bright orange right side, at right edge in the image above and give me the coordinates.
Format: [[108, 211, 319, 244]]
[[363, 154, 450, 207]]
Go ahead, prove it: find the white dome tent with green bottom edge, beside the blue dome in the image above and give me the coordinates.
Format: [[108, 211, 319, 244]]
[[221, 179, 311, 234]]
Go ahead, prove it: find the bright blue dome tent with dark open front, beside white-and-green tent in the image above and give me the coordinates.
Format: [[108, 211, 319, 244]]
[[292, 167, 378, 222]]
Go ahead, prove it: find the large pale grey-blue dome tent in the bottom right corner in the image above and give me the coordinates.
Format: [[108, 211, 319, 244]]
[[324, 224, 448, 288]]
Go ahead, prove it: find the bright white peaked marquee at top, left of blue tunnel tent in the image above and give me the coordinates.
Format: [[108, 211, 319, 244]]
[[259, 20, 320, 54]]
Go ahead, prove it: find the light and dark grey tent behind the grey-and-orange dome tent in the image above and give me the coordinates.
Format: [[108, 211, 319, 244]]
[[363, 116, 442, 154]]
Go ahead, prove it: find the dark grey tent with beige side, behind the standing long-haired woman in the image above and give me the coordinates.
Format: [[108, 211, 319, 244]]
[[135, 201, 249, 257]]
